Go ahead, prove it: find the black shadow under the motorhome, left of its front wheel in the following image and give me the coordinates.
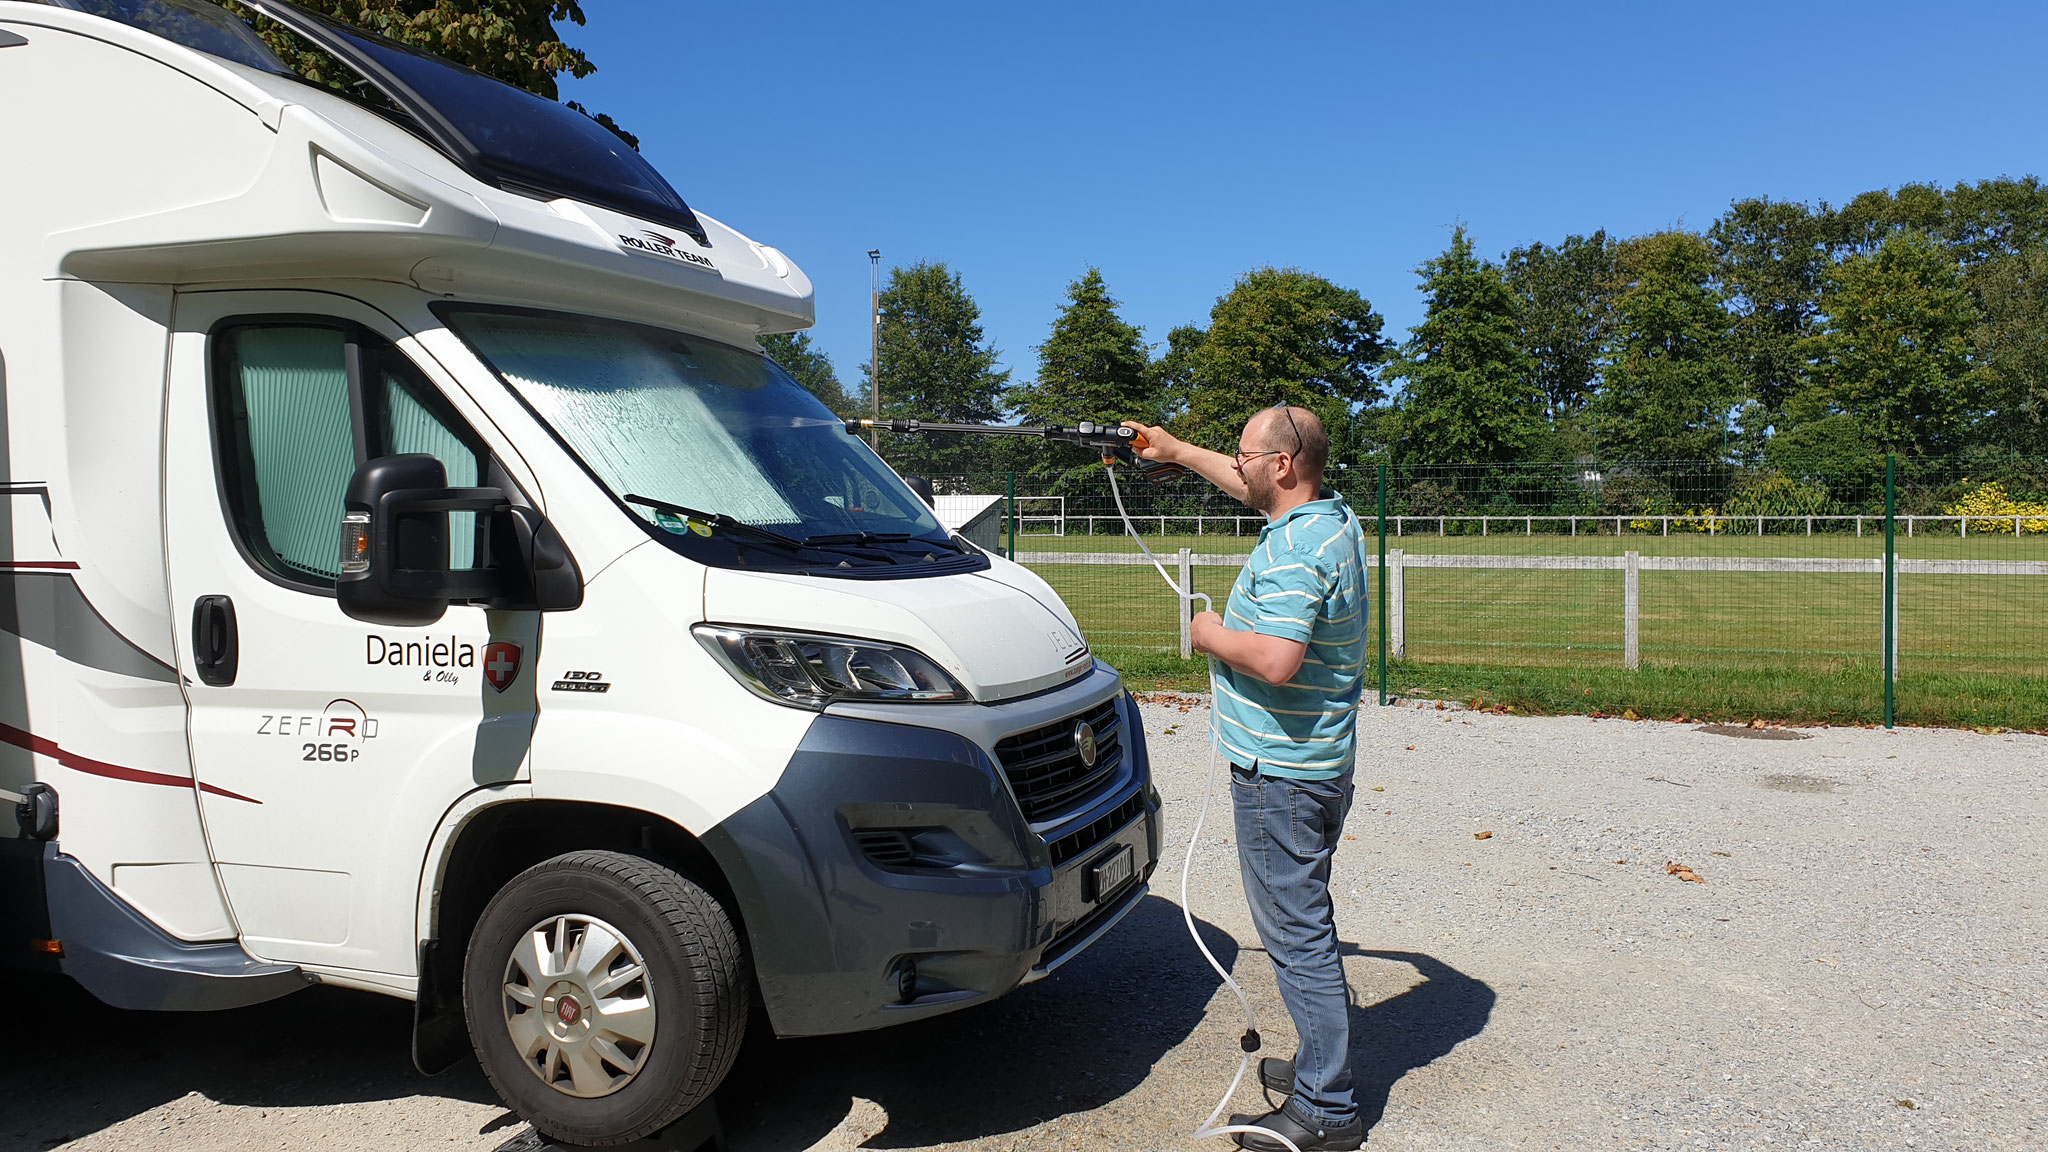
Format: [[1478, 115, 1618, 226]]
[[0, 976, 498, 1150]]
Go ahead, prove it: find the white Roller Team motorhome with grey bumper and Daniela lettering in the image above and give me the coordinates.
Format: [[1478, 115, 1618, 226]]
[[0, 0, 1159, 1144]]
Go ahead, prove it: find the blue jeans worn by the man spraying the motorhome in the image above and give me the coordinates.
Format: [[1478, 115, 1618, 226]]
[[1231, 765, 1358, 1127]]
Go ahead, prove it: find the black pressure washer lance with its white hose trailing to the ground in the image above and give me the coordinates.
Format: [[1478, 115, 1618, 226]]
[[846, 412, 1300, 1152]]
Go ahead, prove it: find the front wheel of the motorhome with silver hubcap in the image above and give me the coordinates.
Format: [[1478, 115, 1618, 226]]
[[463, 851, 750, 1146]]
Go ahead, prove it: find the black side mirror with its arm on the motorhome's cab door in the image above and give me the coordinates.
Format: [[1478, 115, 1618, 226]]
[[334, 453, 584, 627]]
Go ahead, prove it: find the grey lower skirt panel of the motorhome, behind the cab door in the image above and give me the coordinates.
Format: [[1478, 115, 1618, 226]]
[[10, 842, 311, 1013]]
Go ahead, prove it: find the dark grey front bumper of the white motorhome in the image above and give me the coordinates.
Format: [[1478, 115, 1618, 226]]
[[705, 672, 1159, 1035]]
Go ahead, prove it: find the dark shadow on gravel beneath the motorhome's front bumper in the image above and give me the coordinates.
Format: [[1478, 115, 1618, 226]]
[[719, 896, 1237, 1152]]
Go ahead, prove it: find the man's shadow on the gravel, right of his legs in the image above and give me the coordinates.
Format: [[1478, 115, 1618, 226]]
[[1339, 943, 1499, 1134]]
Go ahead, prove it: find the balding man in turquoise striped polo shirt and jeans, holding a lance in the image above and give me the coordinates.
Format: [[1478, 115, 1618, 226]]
[[1128, 404, 1366, 1152]]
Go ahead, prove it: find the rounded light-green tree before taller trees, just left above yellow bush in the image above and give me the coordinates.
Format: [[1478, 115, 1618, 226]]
[[1792, 230, 1989, 455]]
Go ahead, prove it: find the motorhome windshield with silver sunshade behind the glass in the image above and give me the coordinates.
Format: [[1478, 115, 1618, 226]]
[[436, 305, 985, 576]]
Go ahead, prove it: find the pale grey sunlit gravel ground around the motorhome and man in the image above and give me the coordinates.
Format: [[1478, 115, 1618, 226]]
[[16, 701, 2048, 1152]]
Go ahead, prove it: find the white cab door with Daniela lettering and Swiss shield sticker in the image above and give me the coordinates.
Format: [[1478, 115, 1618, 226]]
[[163, 291, 539, 976]]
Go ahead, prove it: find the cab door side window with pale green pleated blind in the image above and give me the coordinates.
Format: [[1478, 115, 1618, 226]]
[[213, 318, 487, 588]]
